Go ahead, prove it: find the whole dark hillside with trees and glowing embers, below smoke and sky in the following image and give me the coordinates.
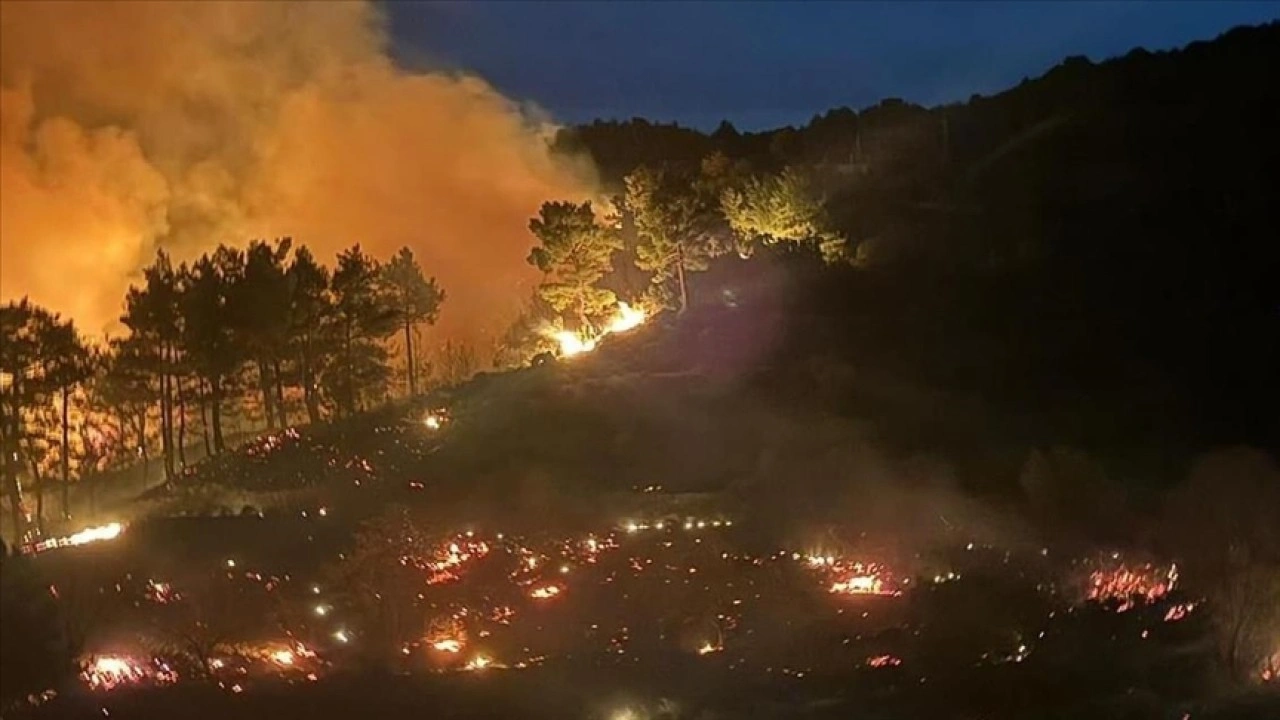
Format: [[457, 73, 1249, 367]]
[[0, 26, 1280, 720]]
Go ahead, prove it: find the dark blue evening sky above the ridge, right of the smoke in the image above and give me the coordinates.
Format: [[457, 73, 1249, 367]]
[[387, 0, 1280, 129]]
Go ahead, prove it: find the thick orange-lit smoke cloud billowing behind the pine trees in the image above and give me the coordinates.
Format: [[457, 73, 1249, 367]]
[[0, 3, 593, 347]]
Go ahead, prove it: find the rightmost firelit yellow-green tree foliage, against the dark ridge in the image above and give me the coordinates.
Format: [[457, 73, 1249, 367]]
[[721, 168, 846, 263]]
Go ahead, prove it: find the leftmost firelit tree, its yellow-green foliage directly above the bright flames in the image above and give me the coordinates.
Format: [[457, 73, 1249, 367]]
[[527, 201, 622, 328]]
